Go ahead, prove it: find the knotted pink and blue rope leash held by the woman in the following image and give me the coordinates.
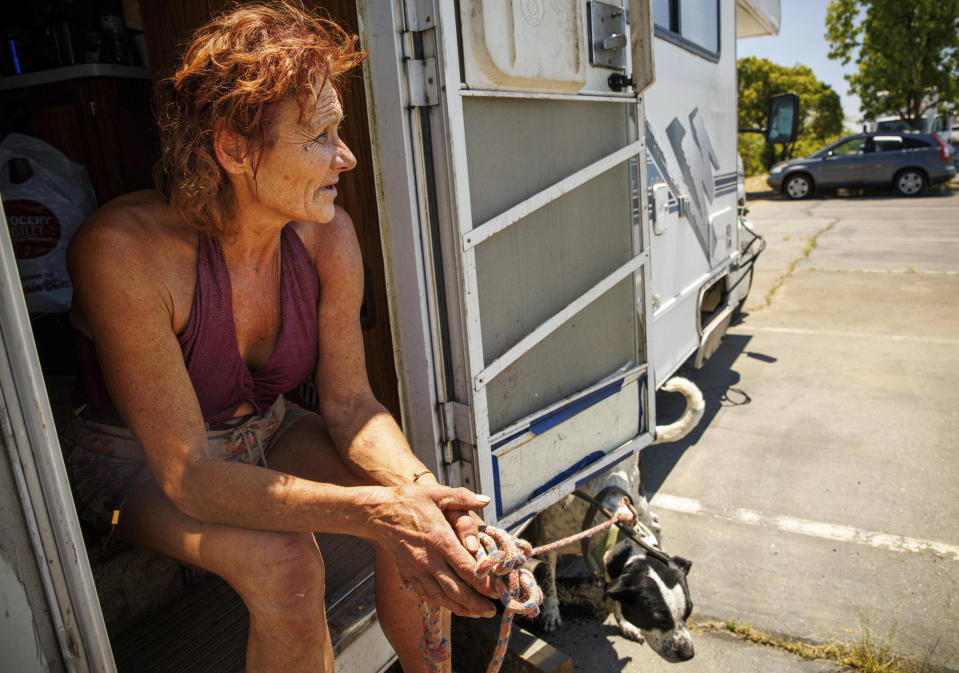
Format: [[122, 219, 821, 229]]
[[419, 506, 636, 673]]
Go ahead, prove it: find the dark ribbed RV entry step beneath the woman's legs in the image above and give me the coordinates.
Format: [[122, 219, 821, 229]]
[[113, 535, 375, 673]]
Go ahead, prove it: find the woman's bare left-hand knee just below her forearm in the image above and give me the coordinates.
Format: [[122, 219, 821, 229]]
[[233, 533, 326, 618]]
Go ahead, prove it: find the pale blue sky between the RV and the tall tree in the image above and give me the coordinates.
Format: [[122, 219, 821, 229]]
[[736, 0, 860, 130]]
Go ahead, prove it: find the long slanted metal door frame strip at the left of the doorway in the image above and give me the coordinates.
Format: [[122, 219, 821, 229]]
[[0, 205, 116, 673]]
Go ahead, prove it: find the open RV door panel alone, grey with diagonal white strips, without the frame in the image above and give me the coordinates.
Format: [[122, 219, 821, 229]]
[[430, 0, 650, 526]]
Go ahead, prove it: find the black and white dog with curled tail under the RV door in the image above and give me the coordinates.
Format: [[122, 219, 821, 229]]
[[532, 378, 704, 662]]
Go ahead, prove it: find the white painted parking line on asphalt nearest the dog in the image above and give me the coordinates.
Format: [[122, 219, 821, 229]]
[[650, 493, 959, 561]]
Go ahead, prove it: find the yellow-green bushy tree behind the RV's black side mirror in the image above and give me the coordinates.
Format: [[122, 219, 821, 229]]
[[737, 56, 843, 175]]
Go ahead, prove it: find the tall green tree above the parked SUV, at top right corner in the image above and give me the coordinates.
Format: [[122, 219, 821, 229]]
[[826, 0, 959, 128]]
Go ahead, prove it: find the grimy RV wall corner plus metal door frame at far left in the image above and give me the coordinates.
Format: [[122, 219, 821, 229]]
[[0, 206, 116, 673]]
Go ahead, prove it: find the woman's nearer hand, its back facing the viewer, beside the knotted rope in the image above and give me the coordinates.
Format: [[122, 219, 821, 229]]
[[371, 484, 496, 617]]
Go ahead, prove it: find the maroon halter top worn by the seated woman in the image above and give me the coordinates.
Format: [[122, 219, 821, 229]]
[[77, 225, 320, 424]]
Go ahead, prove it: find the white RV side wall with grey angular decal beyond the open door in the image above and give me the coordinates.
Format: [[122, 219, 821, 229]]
[[644, 0, 738, 387]]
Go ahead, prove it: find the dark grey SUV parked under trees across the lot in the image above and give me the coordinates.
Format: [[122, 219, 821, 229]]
[[766, 131, 956, 199]]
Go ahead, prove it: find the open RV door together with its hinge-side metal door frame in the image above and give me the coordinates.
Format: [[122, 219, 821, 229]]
[[361, 0, 654, 527]]
